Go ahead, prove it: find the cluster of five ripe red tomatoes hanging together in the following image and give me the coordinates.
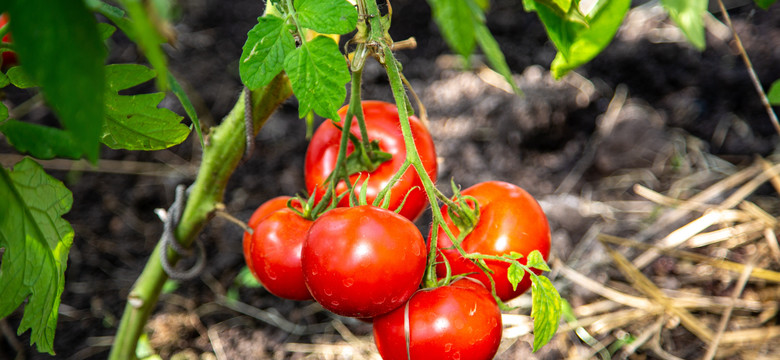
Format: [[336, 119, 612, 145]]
[[243, 101, 550, 359]]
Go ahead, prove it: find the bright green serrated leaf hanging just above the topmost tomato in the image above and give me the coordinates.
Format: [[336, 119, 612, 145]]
[[284, 36, 350, 119]]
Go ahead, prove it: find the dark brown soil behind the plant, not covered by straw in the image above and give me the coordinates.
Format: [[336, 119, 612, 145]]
[[0, 0, 780, 360]]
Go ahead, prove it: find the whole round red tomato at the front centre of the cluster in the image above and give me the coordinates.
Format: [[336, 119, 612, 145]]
[[301, 205, 427, 318]]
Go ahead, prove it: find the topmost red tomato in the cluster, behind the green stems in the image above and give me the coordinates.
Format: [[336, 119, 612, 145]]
[[305, 101, 437, 221]]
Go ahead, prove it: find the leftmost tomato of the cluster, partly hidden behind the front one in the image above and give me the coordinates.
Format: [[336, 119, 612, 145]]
[[244, 197, 312, 300]]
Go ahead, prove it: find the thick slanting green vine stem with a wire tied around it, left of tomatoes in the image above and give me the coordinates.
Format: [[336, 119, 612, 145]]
[[109, 74, 292, 360]]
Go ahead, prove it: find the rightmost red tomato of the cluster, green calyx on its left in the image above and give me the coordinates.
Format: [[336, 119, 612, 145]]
[[436, 181, 550, 301]]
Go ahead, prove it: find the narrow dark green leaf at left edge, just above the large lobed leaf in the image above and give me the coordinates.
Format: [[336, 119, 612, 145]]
[[0, 120, 83, 159]]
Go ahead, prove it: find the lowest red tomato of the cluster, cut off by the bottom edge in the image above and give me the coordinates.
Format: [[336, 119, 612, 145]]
[[374, 278, 503, 360]]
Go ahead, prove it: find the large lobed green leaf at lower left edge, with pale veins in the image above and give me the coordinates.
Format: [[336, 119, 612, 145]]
[[0, 158, 73, 355]]
